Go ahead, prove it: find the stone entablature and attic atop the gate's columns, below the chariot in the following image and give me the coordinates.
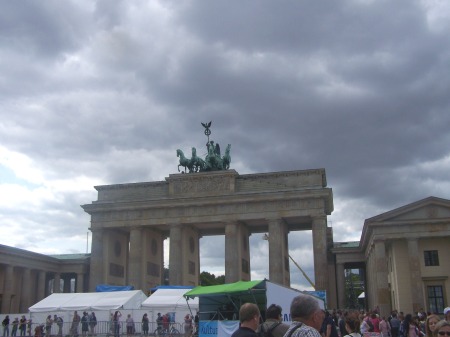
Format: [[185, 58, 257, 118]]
[[83, 169, 333, 231]]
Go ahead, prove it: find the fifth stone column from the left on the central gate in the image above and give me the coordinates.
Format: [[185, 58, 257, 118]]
[[268, 219, 290, 287]]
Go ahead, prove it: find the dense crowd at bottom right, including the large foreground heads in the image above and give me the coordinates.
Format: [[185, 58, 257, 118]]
[[231, 295, 450, 337]]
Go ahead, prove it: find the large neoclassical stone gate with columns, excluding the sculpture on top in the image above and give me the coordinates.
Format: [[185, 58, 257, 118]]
[[82, 169, 334, 290]]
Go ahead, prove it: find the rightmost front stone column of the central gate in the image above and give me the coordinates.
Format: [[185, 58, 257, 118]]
[[312, 215, 328, 290]]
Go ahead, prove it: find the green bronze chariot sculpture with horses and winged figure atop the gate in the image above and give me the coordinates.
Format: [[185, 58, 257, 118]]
[[177, 122, 231, 173]]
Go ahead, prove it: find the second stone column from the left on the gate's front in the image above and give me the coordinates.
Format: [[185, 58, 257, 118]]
[[128, 227, 143, 289]]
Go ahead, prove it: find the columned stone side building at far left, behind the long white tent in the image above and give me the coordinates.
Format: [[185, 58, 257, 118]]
[[0, 245, 90, 313]]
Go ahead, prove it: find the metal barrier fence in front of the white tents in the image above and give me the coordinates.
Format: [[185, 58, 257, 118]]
[[23, 321, 184, 337]]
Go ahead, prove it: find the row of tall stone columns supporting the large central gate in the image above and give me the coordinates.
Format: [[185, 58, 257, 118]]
[[89, 216, 331, 291]]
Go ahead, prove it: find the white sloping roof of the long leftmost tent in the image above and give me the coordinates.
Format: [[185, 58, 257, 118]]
[[28, 290, 147, 312]]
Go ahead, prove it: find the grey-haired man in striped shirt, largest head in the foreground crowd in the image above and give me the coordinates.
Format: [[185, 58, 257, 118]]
[[284, 295, 325, 337]]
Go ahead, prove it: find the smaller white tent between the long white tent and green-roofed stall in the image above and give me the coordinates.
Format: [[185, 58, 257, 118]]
[[141, 289, 198, 324]]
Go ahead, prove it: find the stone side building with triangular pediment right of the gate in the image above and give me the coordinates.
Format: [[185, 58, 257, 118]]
[[332, 197, 450, 316]]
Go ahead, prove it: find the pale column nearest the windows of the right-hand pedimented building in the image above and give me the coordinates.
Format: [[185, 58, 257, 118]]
[[408, 239, 425, 312]]
